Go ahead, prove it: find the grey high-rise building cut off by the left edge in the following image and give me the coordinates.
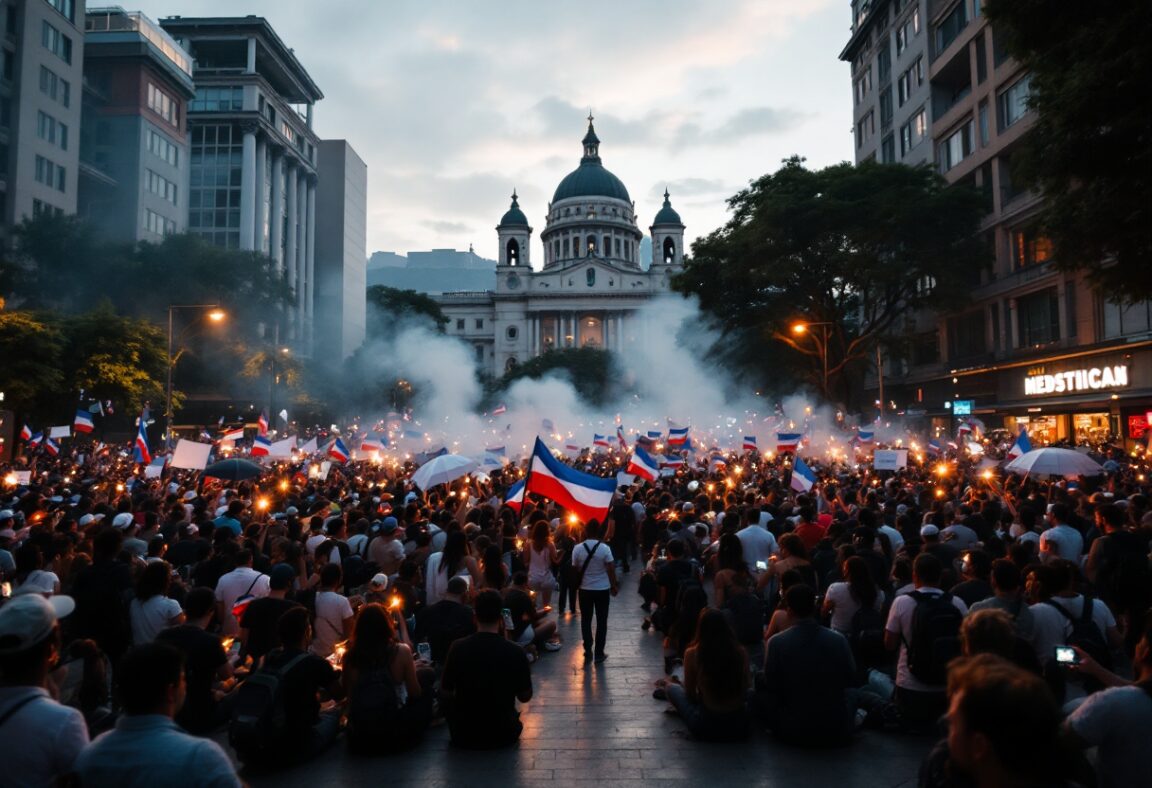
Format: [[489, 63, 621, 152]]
[[0, 0, 84, 235]]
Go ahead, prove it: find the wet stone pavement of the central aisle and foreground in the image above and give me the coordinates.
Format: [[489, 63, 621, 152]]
[[238, 567, 932, 788]]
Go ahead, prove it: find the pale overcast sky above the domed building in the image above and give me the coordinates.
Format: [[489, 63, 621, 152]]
[[139, 0, 852, 262]]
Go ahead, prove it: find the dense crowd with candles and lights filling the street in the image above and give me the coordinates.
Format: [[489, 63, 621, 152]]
[[0, 433, 1152, 786]]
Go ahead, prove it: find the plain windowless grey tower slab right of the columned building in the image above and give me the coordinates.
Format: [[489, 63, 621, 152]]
[[313, 139, 367, 361]]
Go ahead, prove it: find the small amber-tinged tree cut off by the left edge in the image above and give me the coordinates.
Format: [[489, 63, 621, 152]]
[[0, 311, 65, 416]]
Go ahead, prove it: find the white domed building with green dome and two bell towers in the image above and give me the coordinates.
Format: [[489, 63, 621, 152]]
[[437, 116, 684, 377]]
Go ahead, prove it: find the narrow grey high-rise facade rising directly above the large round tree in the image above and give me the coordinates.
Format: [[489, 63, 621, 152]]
[[840, 0, 932, 165]]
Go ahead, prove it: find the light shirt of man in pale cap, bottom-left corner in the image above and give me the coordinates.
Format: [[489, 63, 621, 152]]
[[0, 687, 88, 786]]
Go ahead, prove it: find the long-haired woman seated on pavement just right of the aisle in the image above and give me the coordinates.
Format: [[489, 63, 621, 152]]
[[665, 608, 749, 741]]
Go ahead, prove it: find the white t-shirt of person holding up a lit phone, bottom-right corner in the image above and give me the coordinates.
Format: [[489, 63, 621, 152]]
[[1068, 687, 1152, 788]]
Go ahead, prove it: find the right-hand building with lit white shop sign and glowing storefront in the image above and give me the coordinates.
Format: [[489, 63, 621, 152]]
[[846, 0, 1152, 447]]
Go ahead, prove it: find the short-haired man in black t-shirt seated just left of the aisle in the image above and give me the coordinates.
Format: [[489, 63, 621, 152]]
[[440, 590, 532, 749]]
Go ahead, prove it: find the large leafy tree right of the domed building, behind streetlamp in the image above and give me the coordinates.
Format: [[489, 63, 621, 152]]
[[674, 157, 988, 399]]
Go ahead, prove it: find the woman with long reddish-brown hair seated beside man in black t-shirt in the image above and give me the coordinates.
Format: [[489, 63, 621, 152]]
[[342, 603, 435, 752]]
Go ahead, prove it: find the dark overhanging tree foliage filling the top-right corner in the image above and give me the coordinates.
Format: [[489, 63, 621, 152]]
[[984, 0, 1152, 302]]
